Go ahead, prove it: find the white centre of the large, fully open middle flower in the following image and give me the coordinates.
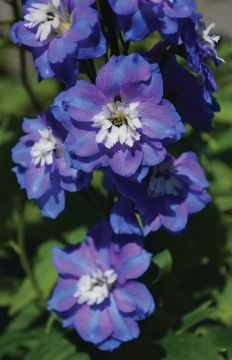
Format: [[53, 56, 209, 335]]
[[93, 101, 142, 149]]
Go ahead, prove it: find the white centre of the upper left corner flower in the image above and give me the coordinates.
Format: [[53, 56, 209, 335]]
[[24, 0, 70, 41]]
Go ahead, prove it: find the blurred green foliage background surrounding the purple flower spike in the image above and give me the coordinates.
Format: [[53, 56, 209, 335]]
[[0, 0, 232, 360]]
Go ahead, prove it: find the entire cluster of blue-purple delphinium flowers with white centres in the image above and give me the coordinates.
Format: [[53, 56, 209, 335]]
[[11, 0, 222, 351]]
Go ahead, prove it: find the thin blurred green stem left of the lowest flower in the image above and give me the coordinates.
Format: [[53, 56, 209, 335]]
[[17, 211, 42, 298]]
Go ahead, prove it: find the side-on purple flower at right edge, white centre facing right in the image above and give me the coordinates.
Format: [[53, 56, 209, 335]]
[[181, 13, 223, 104]]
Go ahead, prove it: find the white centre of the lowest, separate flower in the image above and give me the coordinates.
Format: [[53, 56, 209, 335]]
[[73, 269, 118, 305]]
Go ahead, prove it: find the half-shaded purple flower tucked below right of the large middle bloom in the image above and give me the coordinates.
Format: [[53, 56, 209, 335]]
[[108, 152, 211, 236]]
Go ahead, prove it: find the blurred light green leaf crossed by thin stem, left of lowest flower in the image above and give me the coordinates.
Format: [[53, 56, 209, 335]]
[[10, 240, 59, 315]]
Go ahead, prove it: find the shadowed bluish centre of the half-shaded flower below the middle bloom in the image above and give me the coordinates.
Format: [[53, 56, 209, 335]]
[[147, 164, 183, 198]]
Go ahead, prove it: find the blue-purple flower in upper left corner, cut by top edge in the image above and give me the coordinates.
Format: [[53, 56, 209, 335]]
[[11, 0, 106, 85]]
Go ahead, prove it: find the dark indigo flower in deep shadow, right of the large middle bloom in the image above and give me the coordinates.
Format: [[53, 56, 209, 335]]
[[144, 41, 220, 131]]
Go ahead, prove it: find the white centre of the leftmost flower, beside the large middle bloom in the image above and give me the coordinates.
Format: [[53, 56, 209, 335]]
[[31, 128, 57, 166]]
